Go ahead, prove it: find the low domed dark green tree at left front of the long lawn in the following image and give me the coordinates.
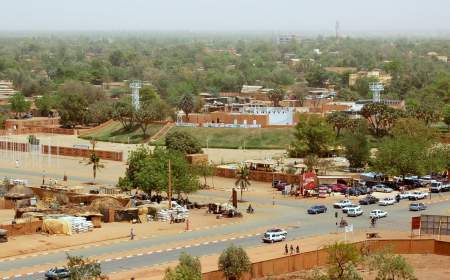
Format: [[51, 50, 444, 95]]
[[165, 131, 203, 154]]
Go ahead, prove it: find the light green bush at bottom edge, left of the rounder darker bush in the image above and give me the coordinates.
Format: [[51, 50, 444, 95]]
[[164, 252, 202, 280]]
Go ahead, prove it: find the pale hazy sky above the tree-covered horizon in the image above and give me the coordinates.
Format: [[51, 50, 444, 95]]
[[0, 0, 450, 32]]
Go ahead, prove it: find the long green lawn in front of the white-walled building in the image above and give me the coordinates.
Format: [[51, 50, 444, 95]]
[[152, 127, 294, 149]]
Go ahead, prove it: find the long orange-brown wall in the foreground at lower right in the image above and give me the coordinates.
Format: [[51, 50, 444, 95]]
[[202, 239, 450, 280]]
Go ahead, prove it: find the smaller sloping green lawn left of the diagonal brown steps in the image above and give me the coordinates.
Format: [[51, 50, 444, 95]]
[[80, 122, 163, 144]]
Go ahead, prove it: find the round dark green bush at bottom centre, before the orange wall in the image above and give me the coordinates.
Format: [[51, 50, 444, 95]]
[[218, 245, 251, 280]]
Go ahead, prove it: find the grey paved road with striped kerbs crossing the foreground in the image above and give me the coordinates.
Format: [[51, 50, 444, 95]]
[[0, 194, 450, 279]]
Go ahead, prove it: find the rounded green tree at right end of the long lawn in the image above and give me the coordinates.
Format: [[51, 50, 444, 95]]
[[289, 115, 334, 157]]
